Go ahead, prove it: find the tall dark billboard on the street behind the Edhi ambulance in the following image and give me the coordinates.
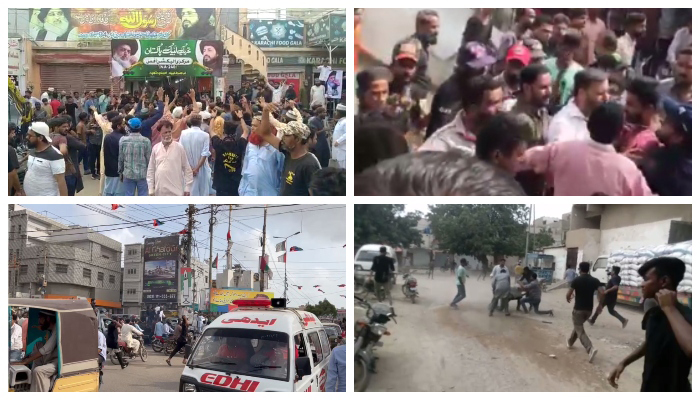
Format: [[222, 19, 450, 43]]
[[143, 235, 180, 303]]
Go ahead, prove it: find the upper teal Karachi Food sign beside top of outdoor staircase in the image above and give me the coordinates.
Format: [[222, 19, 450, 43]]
[[248, 19, 304, 47]]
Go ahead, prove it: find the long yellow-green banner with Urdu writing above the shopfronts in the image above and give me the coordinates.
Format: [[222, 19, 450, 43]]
[[28, 8, 216, 41]]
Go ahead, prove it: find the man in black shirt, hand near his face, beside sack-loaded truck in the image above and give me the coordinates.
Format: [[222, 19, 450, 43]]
[[608, 257, 693, 392]]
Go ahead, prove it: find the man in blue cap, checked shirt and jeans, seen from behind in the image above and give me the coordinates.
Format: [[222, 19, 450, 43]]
[[119, 118, 151, 196]]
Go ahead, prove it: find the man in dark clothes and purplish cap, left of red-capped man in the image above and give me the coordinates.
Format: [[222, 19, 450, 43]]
[[425, 42, 496, 138]]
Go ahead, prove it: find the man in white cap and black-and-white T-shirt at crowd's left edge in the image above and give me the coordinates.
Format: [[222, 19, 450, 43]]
[[24, 122, 68, 196]]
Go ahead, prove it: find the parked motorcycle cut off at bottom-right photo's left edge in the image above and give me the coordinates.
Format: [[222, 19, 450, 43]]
[[355, 296, 396, 392]]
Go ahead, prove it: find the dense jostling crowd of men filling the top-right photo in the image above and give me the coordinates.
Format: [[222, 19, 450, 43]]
[[355, 8, 692, 196]]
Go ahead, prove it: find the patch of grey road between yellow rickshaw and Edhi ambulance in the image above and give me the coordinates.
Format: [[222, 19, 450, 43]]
[[100, 346, 184, 392]]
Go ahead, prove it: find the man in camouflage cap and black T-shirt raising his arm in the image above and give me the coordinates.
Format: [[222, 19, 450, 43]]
[[256, 103, 321, 196]]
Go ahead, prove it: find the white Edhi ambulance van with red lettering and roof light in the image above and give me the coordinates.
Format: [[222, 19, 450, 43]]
[[180, 299, 331, 392]]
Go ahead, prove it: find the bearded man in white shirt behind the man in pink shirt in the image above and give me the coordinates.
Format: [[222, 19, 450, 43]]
[[545, 69, 608, 143]]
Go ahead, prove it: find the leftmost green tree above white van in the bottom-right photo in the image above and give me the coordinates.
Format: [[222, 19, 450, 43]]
[[355, 204, 421, 247]]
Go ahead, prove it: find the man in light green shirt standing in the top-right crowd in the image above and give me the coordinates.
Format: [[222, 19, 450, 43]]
[[544, 31, 583, 106]]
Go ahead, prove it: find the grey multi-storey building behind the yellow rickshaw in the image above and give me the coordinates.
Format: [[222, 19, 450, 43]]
[[9, 209, 122, 309]]
